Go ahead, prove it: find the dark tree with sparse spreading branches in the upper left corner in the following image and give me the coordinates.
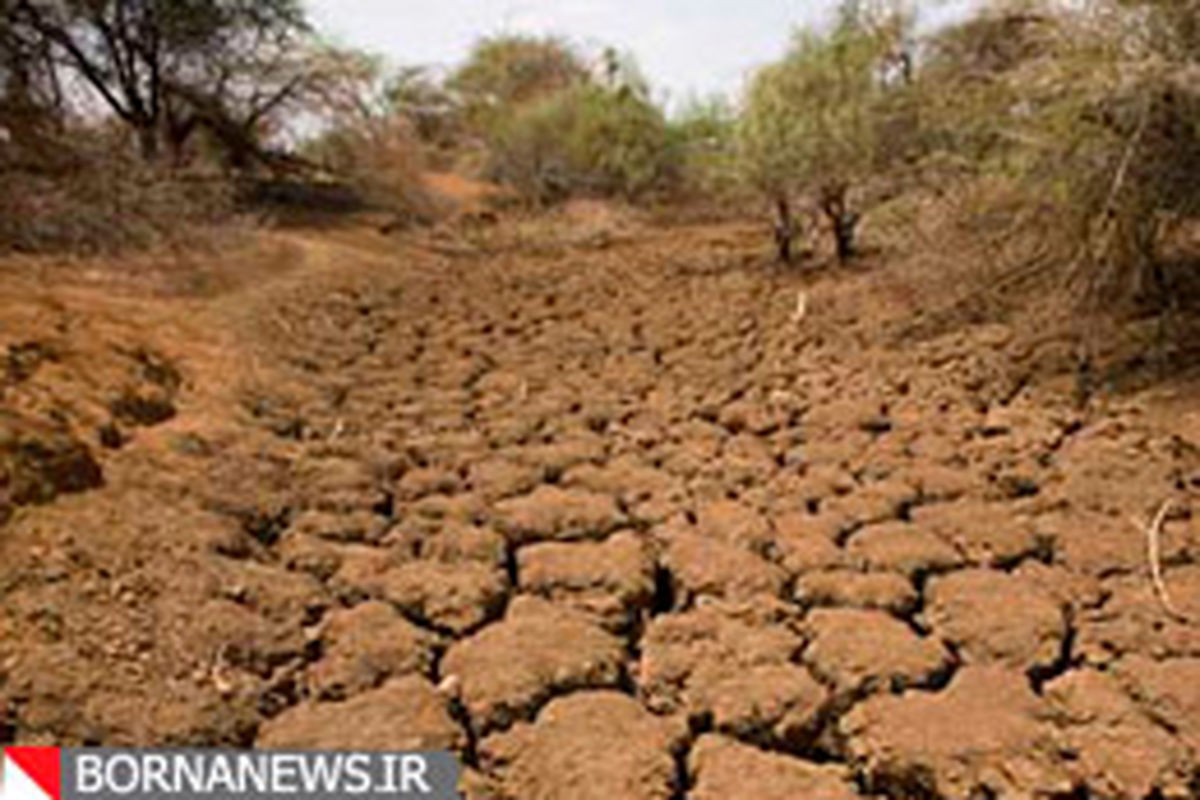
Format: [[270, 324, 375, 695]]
[[0, 0, 307, 161]]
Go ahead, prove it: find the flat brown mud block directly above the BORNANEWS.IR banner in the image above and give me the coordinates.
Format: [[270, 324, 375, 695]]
[[256, 675, 467, 751]]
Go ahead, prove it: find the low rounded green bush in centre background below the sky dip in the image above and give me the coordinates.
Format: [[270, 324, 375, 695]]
[[491, 83, 678, 203]]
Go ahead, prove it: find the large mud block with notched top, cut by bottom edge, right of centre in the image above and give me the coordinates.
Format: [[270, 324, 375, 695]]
[[839, 667, 1074, 800]]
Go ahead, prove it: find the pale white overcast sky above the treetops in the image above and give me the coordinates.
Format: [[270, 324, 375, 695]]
[[308, 0, 970, 101]]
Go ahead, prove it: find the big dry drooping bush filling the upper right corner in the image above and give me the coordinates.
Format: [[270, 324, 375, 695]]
[[924, 0, 1200, 313]]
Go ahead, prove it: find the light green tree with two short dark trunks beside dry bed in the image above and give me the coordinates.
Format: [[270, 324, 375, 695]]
[[738, 2, 910, 263]]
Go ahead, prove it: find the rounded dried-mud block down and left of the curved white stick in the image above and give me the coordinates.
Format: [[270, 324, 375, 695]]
[[924, 570, 1067, 670]]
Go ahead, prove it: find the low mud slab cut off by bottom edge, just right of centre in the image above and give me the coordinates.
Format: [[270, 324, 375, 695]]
[[688, 735, 858, 800]]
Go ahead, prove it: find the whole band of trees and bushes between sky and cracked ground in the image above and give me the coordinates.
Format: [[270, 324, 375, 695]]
[[0, 0, 1200, 345]]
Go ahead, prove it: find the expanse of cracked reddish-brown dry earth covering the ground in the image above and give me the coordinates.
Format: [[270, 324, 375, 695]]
[[0, 215, 1200, 800]]
